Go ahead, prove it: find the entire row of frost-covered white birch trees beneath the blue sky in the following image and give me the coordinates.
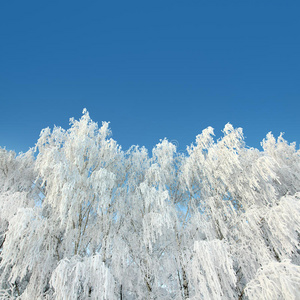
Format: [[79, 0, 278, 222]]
[[0, 110, 300, 300]]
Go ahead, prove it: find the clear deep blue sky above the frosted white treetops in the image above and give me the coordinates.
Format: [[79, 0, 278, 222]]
[[0, 0, 300, 152]]
